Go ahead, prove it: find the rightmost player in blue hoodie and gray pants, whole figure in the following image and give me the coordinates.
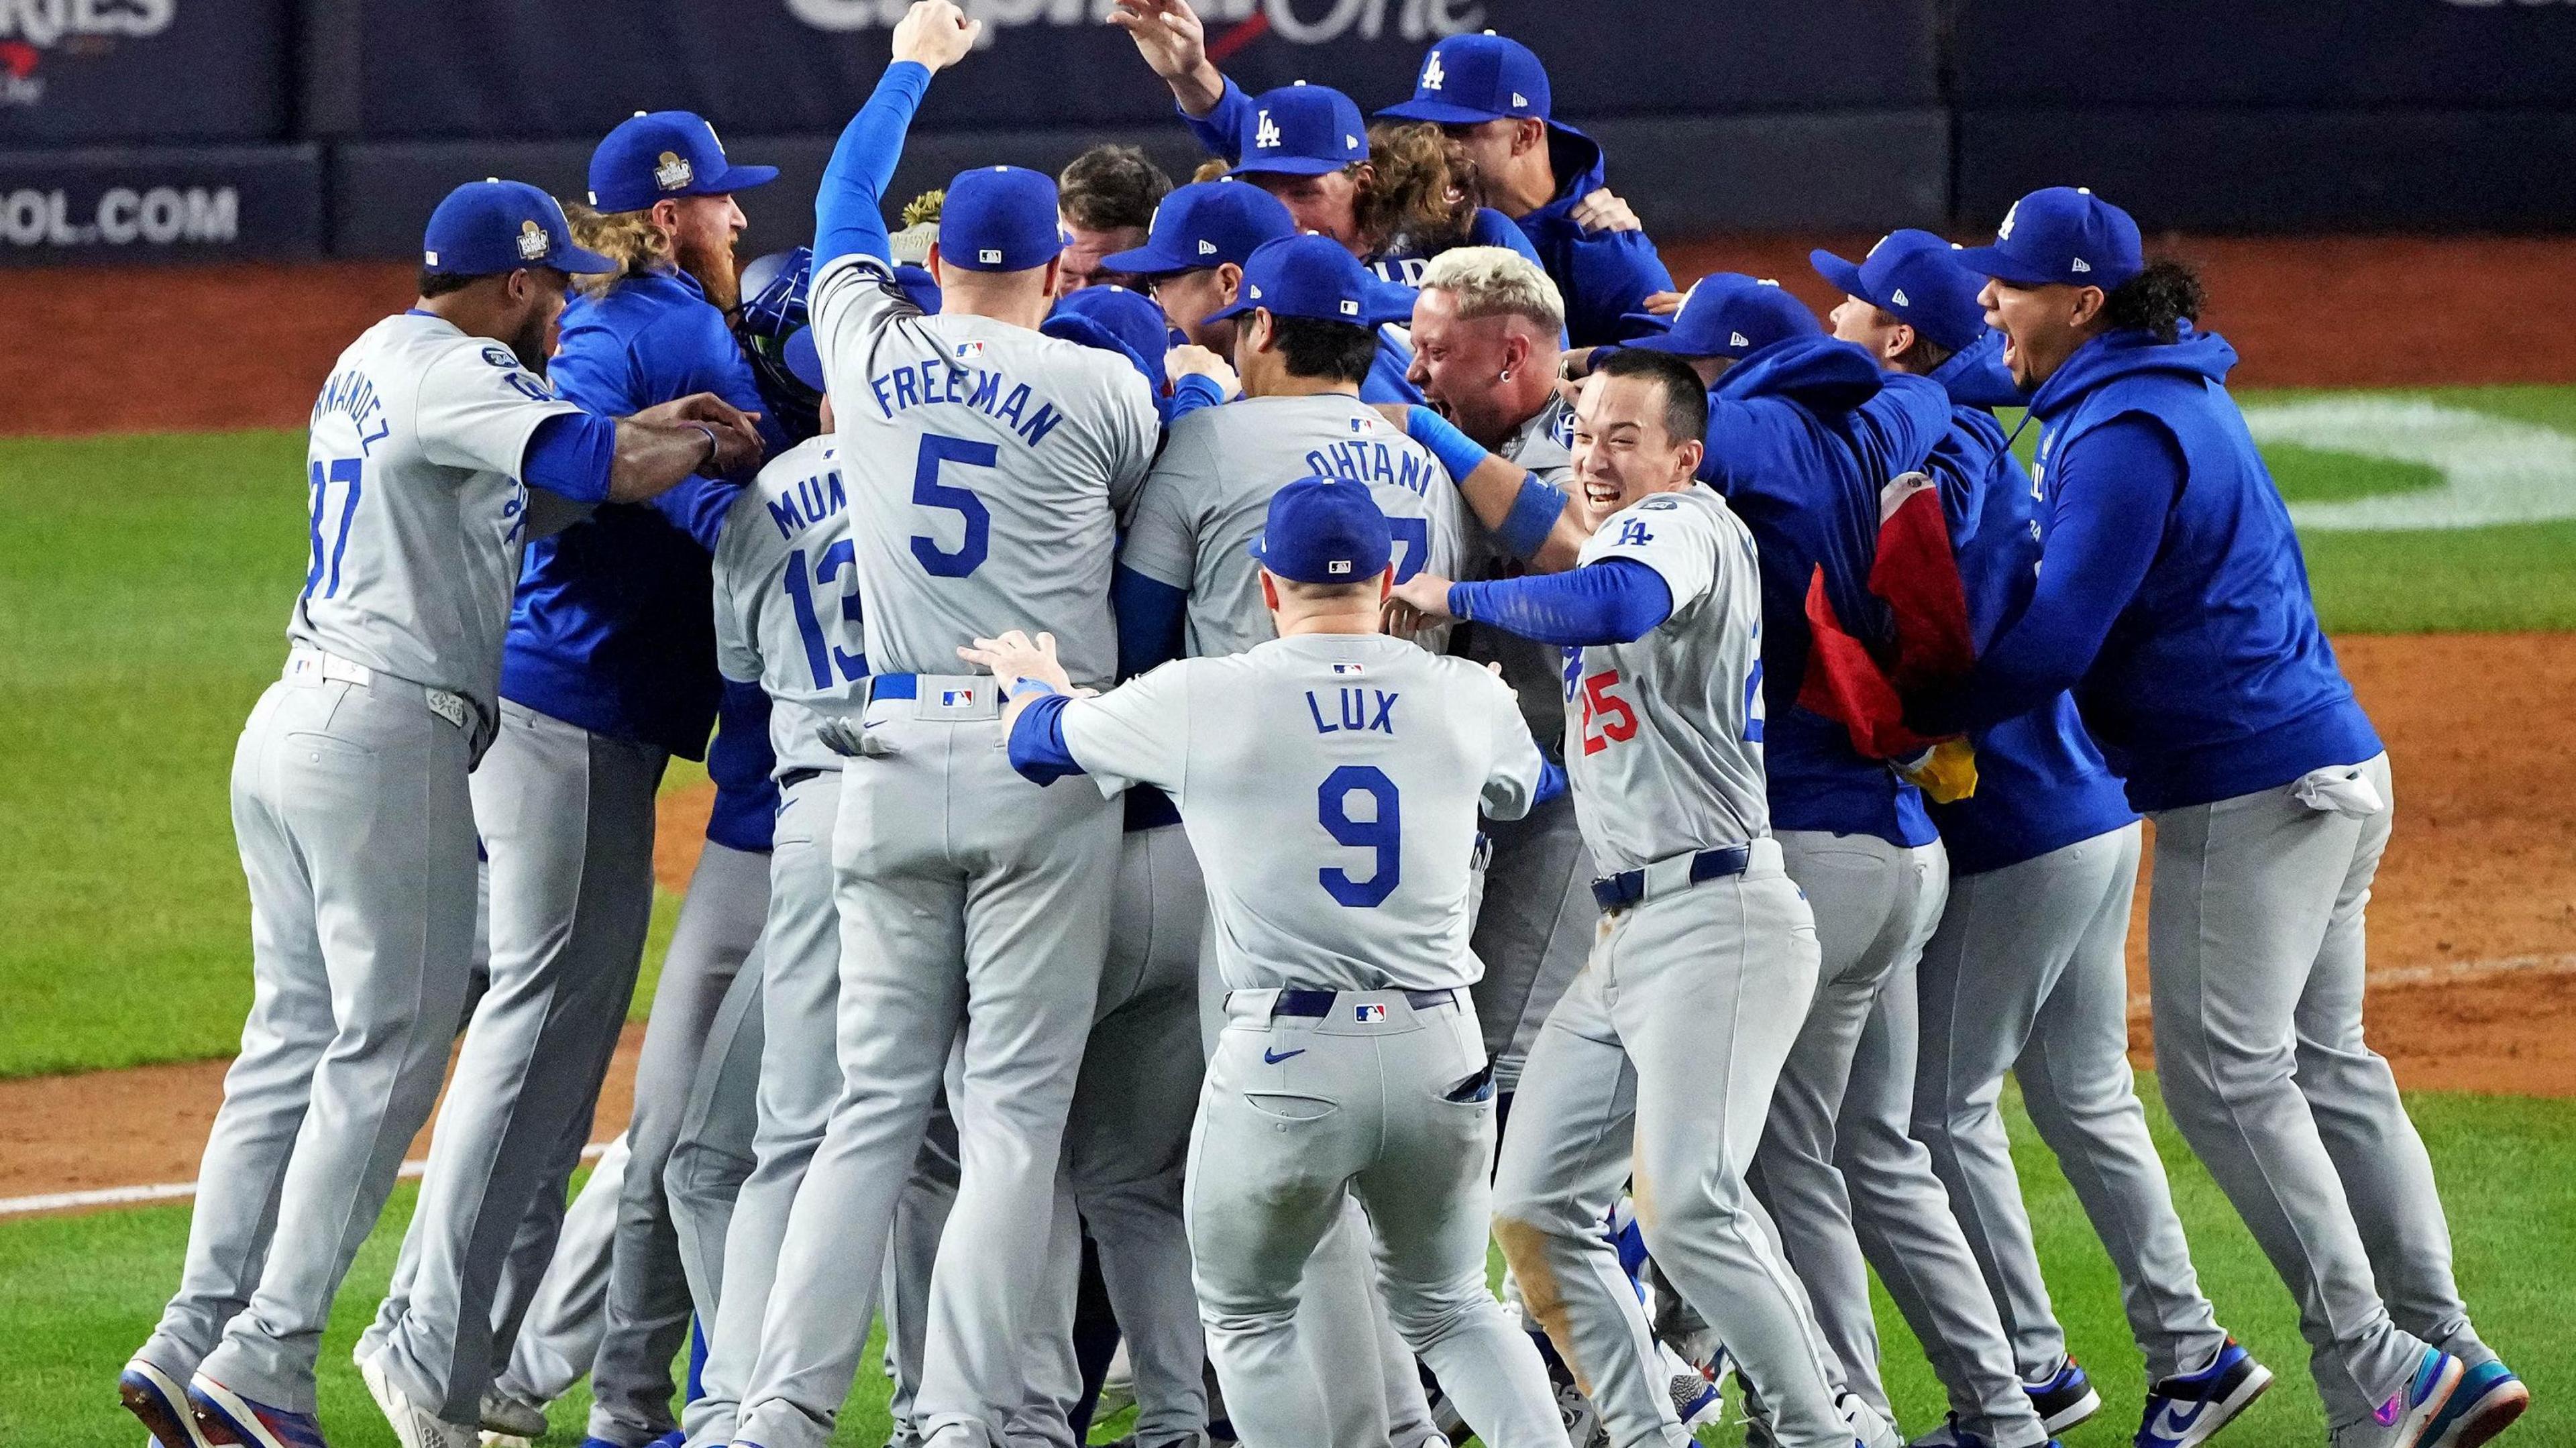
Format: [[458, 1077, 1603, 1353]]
[[1907, 186, 2530, 1448]]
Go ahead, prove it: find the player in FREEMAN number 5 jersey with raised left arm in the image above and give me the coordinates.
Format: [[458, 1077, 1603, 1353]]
[[734, 11, 1159, 1448]]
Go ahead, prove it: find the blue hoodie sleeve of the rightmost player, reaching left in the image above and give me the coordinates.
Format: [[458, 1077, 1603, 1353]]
[[1907, 415, 2184, 734]]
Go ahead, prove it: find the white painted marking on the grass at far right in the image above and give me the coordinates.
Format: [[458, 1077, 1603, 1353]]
[[2244, 397, 2576, 533]]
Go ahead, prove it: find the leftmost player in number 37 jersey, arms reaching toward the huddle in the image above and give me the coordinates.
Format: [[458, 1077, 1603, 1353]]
[[119, 180, 760, 1448]]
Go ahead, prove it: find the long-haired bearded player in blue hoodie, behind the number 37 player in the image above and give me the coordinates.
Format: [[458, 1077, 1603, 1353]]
[[358, 111, 783, 1448]]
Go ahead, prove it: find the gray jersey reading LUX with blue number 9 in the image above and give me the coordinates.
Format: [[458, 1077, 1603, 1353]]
[[1064, 634, 1543, 989]]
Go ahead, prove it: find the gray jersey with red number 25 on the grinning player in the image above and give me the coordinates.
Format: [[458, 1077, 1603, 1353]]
[[1566, 482, 1770, 873]]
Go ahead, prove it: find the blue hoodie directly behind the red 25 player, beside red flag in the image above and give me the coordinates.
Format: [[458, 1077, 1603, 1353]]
[[1700, 337, 1950, 845]]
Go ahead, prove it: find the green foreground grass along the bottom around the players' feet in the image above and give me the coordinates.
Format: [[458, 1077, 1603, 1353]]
[[0, 1080, 2576, 1448]]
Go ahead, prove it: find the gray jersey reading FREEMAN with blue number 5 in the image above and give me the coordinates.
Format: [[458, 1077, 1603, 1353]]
[[814, 255, 1162, 683]]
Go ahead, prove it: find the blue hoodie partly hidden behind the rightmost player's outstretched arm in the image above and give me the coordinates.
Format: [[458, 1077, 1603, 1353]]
[[1924, 333, 2135, 876]]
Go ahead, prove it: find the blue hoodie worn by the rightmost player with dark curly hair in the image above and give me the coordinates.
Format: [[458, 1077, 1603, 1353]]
[[1909, 330, 2380, 812]]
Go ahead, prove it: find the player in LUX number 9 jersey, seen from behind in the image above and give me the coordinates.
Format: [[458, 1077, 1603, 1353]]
[[961, 477, 1564, 1448]]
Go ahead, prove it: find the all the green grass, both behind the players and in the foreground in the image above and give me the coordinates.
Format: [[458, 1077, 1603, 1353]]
[[0, 386, 2576, 1448]]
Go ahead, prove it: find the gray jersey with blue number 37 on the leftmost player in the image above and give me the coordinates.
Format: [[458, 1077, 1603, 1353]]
[[286, 312, 580, 722]]
